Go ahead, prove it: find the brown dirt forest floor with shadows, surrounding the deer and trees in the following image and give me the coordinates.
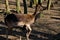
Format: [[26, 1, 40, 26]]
[[0, 0, 60, 40]]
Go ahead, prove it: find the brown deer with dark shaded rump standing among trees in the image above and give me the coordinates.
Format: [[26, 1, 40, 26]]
[[4, 4, 43, 40]]
